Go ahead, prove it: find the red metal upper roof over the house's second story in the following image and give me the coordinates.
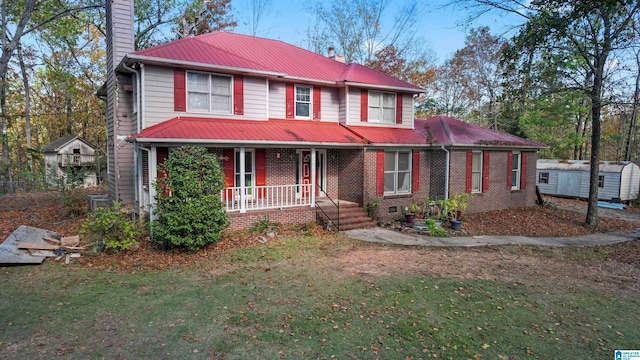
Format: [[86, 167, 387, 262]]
[[128, 31, 422, 92]]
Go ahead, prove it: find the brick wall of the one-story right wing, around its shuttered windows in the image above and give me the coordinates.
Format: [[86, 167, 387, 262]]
[[449, 150, 536, 213]]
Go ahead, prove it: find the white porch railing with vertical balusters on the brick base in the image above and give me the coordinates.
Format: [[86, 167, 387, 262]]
[[220, 184, 311, 212]]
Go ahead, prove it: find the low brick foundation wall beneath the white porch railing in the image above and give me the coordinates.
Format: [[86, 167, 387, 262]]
[[227, 206, 316, 230]]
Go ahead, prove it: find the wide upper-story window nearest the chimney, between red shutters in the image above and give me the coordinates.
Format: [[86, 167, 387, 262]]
[[187, 72, 231, 114]]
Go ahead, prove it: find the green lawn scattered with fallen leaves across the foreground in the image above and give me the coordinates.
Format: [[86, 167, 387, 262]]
[[0, 237, 640, 359]]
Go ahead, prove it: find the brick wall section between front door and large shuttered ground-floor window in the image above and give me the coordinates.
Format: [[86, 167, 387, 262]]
[[338, 149, 364, 206]]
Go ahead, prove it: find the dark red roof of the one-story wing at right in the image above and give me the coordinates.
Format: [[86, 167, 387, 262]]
[[414, 116, 547, 148]]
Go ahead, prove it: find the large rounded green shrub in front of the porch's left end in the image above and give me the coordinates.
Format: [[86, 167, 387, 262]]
[[152, 146, 229, 251]]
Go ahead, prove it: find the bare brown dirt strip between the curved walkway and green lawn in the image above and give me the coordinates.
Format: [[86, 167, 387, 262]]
[[336, 246, 640, 291]]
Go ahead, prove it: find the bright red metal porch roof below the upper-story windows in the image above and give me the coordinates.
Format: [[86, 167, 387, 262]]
[[128, 116, 365, 146]]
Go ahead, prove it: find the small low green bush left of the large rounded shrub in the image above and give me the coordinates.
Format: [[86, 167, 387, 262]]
[[80, 202, 146, 252]]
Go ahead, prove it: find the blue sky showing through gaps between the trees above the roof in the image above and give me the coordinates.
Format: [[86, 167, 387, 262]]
[[232, 0, 520, 64]]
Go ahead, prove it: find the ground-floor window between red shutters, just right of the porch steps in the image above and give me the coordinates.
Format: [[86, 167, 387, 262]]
[[384, 151, 411, 195]]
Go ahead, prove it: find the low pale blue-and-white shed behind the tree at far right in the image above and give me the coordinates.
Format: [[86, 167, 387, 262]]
[[536, 159, 640, 201]]
